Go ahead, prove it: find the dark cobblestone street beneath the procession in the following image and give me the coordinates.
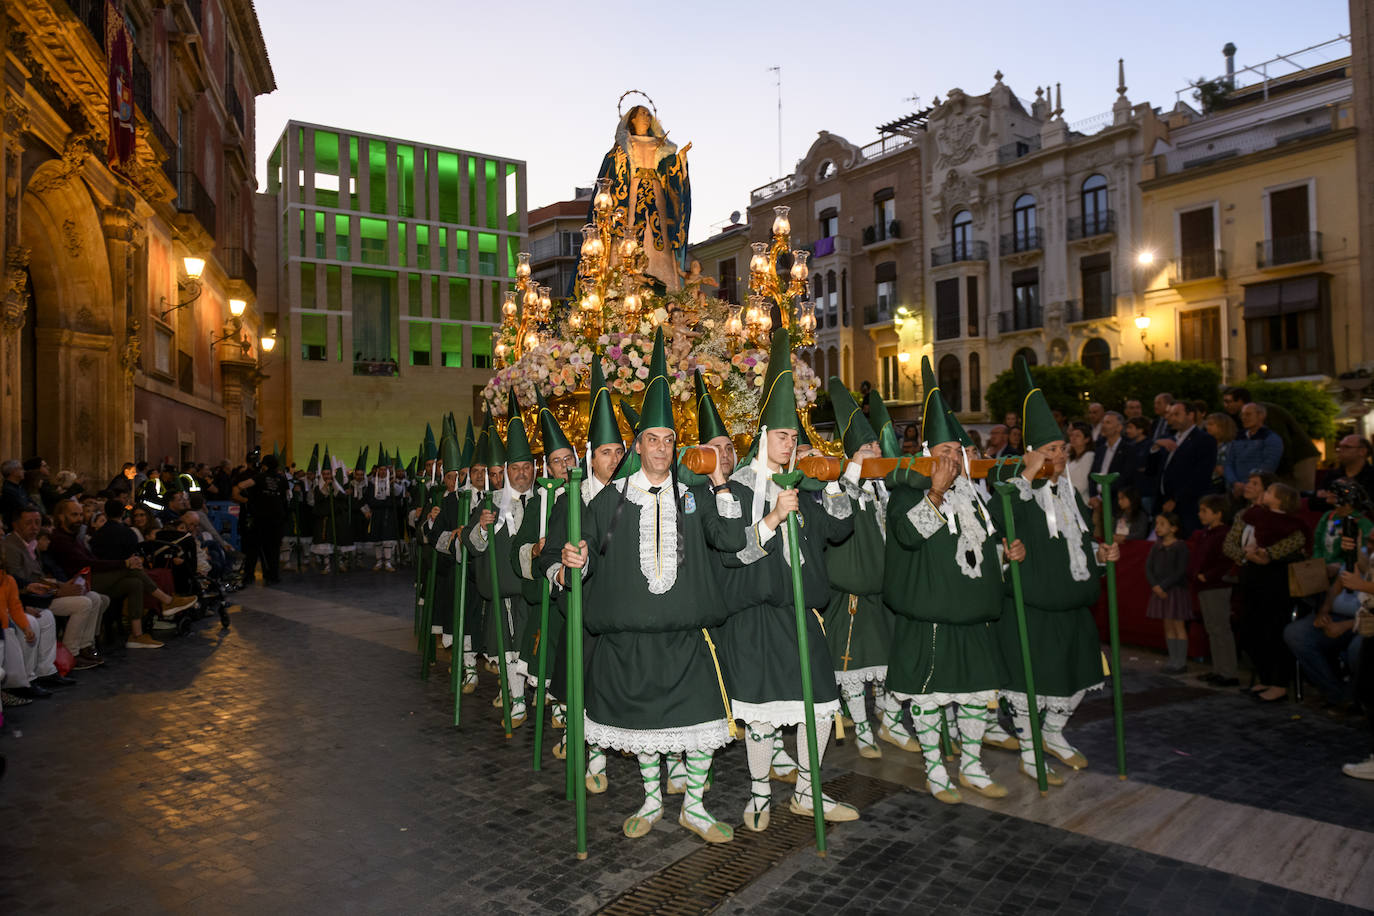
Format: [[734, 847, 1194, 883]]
[[0, 571, 1374, 916]]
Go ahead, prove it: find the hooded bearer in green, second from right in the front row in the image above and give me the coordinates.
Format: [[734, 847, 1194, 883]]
[[883, 357, 1025, 805]]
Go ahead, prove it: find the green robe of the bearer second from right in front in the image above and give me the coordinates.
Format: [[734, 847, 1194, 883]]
[[883, 488, 1007, 702]]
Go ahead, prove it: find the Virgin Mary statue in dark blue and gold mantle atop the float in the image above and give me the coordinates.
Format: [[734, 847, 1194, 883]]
[[588, 97, 691, 293]]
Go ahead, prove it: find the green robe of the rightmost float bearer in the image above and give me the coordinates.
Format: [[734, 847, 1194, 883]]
[[993, 475, 1106, 696]]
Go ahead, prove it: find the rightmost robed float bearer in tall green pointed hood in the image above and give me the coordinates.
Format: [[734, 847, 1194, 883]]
[[993, 357, 1120, 786]]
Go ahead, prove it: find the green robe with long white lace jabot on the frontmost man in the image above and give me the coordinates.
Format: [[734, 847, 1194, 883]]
[[583, 471, 745, 753]]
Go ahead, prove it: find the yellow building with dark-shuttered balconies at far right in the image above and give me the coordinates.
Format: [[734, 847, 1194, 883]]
[[1140, 36, 1357, 380]]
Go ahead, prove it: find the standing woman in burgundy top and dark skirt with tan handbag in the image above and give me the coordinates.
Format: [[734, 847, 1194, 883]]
[[1224, 483, 1312, 703]]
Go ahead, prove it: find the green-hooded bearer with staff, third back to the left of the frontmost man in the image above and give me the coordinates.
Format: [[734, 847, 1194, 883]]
[[463, 401, 539, 728]]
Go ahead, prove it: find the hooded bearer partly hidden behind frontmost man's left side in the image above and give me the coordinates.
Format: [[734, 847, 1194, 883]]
[[534, 354, 629, 795]]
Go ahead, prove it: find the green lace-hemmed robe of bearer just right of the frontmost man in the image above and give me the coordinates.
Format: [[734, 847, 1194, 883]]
[[720, 464, 853, 725]]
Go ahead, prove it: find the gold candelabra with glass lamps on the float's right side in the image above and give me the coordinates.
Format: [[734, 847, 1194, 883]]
[[725, 206, 816, 349]]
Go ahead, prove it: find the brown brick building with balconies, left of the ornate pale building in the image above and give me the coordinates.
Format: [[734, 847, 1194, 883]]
[[747, 127, 925, 401]]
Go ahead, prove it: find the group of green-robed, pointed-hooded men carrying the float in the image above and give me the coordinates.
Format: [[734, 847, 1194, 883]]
[[420, 330, 1114, 842]]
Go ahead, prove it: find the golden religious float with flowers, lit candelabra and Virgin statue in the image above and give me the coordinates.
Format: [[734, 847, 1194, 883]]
[[482, 91, 838, 453]]
